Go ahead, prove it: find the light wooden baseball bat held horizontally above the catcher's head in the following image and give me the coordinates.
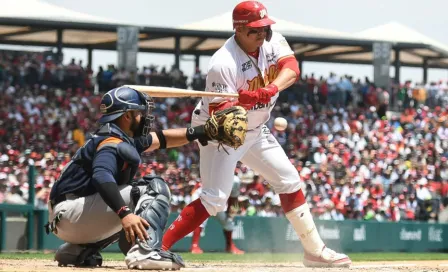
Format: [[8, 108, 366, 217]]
[[126, 85, 238, 97]]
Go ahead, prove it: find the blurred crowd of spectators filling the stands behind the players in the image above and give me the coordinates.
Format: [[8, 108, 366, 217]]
[[0, 51, 448, 222]]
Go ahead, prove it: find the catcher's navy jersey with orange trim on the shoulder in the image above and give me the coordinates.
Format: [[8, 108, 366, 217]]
[[50, 124, 151, 199]]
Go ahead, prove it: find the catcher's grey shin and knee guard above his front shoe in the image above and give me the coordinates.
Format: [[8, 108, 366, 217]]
[[119, 176, 171, 254]]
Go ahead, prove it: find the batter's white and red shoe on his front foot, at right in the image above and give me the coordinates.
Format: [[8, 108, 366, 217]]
[[303, 247, 352, 267]]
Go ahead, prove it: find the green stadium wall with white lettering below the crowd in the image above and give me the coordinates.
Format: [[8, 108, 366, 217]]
[[0, 210, 448, 253]]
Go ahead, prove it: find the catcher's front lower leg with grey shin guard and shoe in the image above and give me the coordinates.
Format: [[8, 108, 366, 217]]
[[123, 176, 185, 270]]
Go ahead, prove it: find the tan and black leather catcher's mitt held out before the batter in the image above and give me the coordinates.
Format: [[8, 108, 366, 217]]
[[204, 106, 247, 149]]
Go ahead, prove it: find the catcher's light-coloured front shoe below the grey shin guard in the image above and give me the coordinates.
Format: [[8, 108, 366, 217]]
[[125, 250, 185, 270]]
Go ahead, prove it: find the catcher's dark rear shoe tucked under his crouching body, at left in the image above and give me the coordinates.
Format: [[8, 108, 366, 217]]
[[54, 233, 119, 267]]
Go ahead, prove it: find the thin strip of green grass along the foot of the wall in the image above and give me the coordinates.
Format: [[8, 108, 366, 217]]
[[0, 252, 448, 263]]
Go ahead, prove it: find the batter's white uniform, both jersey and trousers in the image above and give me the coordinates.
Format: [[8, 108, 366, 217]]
[[191, 33, 301, 217]]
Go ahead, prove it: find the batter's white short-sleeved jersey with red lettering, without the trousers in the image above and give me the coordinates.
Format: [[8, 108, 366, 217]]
[[196, 32, 294, 130]]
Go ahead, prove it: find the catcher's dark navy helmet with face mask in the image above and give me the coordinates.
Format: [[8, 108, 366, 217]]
[[98, 86, 155, 137]]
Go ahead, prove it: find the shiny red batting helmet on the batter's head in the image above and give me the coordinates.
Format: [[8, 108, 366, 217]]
[[232, 1, 275, 28]]
